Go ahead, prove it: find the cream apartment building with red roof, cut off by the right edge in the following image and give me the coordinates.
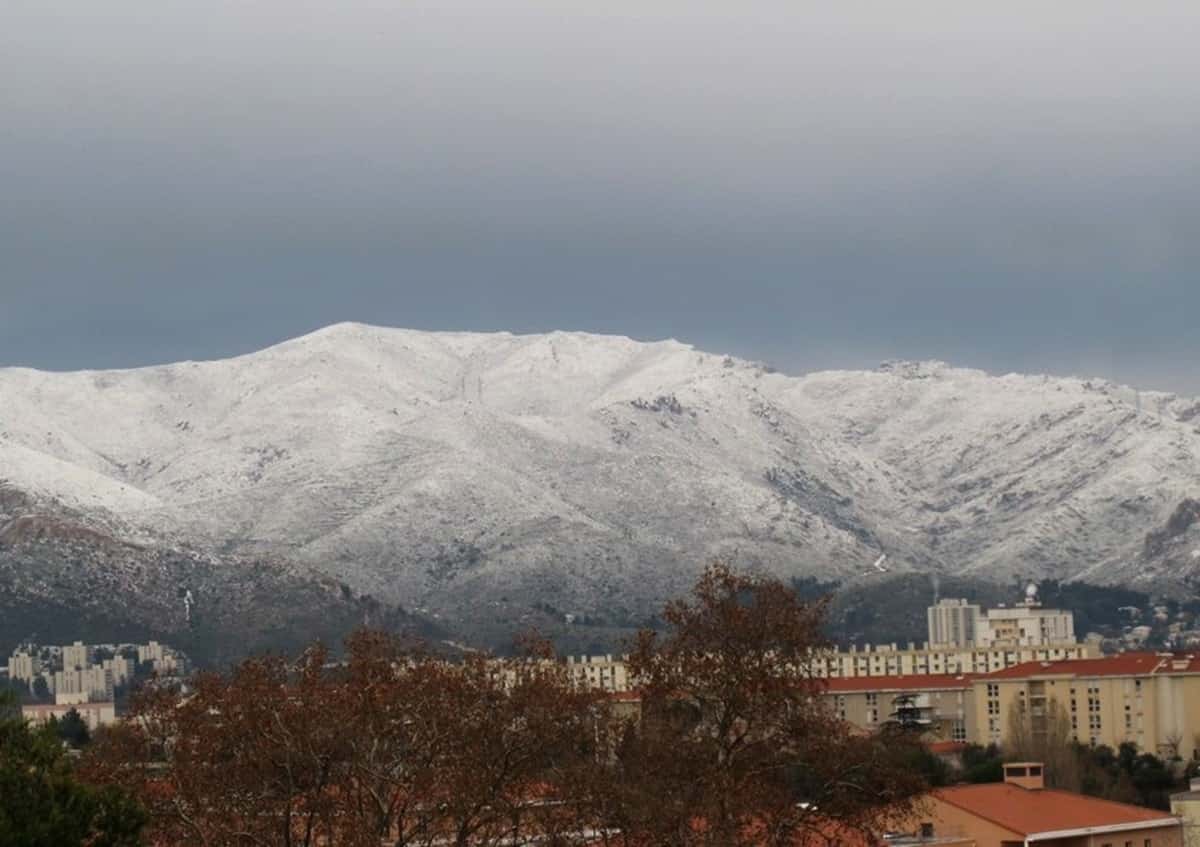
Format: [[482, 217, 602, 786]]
[[973, 653, 1200, 758]]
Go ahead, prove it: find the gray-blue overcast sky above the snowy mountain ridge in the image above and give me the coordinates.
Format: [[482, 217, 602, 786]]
[[0, 0, 1200, 394]]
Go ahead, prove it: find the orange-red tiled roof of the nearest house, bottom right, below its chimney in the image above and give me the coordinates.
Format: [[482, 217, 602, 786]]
[[934, 782, 1176, 836]]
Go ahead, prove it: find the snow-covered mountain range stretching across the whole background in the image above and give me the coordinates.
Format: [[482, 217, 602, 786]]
[[0, 324, 1200, 647]]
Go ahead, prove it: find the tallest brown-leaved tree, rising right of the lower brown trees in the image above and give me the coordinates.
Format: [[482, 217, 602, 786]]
[[614, 565, 925, 847]]
